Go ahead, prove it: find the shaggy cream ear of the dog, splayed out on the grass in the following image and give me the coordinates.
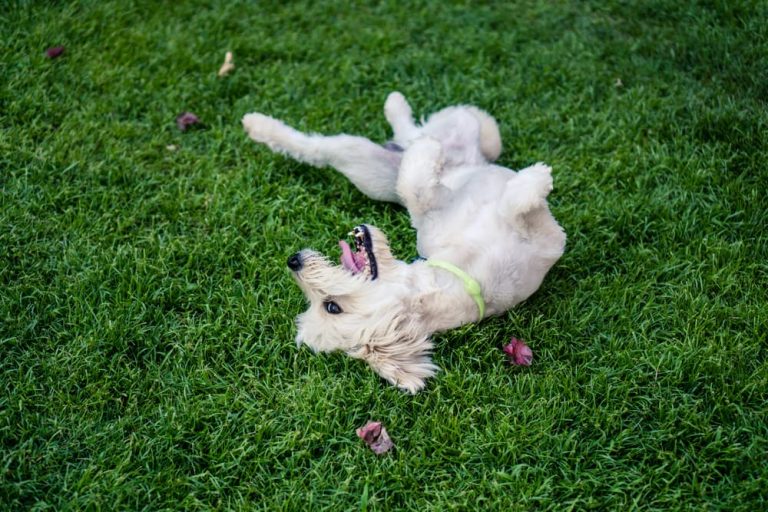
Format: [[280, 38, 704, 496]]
[[348, 331, 440, 394]]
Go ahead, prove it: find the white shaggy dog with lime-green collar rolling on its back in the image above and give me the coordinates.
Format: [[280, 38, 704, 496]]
[[243, 92, 565, 393]]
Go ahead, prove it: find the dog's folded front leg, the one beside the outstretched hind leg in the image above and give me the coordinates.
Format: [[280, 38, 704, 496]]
[[397, 137, 449, 219]]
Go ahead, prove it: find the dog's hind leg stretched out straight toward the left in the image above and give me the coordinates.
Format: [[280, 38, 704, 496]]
[[243, 113, 402, 203]]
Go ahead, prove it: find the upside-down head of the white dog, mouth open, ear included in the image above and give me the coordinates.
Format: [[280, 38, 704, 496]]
[[288, 225, 437, 392]]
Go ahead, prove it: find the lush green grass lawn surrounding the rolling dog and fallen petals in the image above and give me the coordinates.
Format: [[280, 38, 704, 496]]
[[0, 0, 768, 511]]
